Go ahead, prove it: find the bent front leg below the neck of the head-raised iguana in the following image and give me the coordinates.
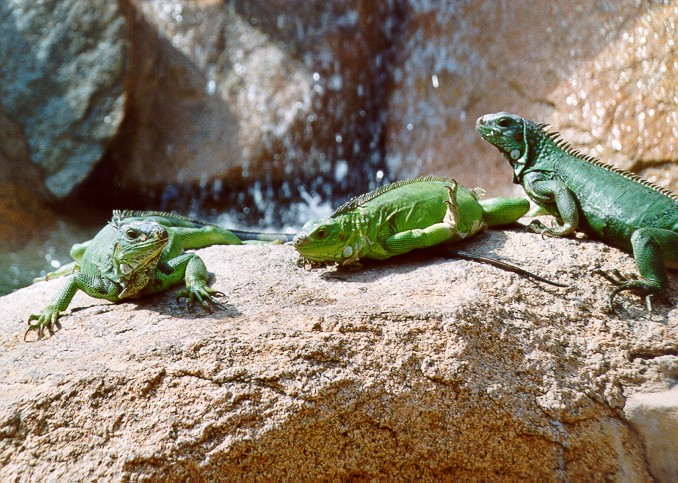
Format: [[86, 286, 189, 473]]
[[523, 173, 579, 237]]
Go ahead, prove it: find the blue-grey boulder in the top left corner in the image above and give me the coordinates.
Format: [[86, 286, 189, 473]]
[[0, 0, 126, 198]]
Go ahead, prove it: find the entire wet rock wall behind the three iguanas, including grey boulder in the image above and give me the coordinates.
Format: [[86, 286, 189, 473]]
[[0, 0, 678, 229]]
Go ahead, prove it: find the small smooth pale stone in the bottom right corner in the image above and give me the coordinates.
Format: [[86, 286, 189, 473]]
[[624, 386, 678, 482]]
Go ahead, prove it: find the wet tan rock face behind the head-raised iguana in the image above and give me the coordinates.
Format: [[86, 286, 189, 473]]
[[386, 0, 678, 194]]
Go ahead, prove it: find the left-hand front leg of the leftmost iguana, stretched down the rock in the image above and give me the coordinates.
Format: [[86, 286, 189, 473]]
[[24, 273, 120, 340]]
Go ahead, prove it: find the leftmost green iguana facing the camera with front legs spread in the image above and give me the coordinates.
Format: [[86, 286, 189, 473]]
[[24, 211, 289, 338]]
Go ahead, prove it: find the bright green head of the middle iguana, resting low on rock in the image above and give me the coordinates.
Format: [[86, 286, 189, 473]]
[[294, 218, 359, 264]]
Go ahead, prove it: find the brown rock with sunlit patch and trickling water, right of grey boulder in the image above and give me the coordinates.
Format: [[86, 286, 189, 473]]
[[105, 0, 398, 204]]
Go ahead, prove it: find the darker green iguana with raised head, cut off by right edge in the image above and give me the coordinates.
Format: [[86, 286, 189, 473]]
[[476, 112, 678, 311]]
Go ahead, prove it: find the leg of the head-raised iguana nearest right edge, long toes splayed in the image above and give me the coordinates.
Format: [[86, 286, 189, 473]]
[[596, 228, 678, 312]]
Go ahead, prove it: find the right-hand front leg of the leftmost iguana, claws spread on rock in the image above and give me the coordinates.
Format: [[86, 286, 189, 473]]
[[143, 253, 224, 312]]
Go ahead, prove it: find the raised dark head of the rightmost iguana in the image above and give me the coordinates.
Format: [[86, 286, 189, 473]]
[[476, 112, 545, 183]]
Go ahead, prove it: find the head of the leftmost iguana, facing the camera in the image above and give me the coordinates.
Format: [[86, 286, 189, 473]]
[[111, 216, 169, 279]]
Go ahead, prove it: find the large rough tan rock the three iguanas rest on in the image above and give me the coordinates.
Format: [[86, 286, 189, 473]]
[[0, 231, 678, 482]]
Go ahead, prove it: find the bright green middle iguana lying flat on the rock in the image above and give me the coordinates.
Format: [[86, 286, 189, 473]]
[[294, 177, 529, 265]]
